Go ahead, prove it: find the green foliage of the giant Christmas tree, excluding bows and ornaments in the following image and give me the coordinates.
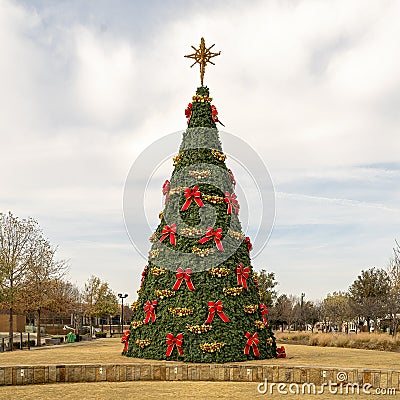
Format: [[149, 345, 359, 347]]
[[127, 87, 276, 362]]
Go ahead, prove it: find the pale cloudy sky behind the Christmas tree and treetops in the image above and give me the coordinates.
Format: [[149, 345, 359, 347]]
[[0, 0, 400, 301]]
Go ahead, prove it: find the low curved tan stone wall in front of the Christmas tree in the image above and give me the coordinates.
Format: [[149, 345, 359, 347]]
[[0, 363, 400, 393]]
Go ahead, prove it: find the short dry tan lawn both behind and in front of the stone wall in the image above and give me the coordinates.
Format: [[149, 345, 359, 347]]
[[0, 339, 400, 400]]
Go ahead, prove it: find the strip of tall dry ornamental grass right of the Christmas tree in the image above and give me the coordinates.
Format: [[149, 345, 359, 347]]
[[276, 332, 400, 351]]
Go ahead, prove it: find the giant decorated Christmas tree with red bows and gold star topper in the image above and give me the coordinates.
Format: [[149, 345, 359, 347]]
[[126, 38, 276, 362]]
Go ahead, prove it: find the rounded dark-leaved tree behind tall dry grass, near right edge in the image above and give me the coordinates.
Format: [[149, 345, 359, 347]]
[[349, 268, 390, 332]]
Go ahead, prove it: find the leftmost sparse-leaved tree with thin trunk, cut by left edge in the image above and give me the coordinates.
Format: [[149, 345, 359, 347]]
[[0, 212, 42, 350]]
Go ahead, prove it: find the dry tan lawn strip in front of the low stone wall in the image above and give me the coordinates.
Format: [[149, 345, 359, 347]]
[[0, 382, 396, 400]]
